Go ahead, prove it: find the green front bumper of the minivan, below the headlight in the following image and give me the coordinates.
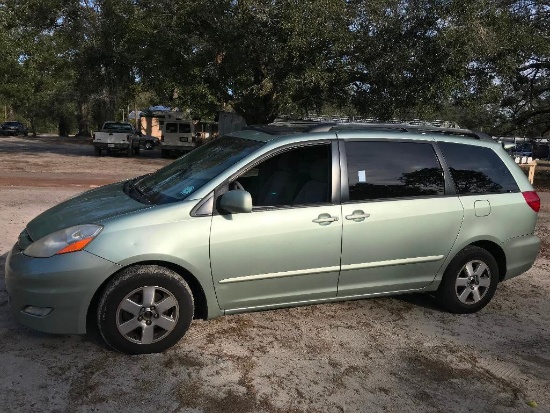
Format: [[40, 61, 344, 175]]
[[6, 244, 120, 334]]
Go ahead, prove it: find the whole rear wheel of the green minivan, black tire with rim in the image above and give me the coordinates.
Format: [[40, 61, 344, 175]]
[[436, 245, 499, 314]]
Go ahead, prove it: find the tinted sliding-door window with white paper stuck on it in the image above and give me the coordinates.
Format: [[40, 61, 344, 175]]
[[346, 141, 445, 201]]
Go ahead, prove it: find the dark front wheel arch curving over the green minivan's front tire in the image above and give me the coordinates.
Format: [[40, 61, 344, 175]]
[[86, 260, 208, 331]]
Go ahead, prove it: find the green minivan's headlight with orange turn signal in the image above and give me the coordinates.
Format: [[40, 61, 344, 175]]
[[23, 224, 103, 258]]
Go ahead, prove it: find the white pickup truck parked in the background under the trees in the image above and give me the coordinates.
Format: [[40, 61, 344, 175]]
[[92, 122, 139, 156]]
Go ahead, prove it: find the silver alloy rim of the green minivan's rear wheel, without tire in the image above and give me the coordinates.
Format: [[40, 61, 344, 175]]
[[455, 260, 491, 304]]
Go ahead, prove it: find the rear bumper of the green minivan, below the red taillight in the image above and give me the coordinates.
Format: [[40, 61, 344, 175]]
[[502, 235, 540, 280]]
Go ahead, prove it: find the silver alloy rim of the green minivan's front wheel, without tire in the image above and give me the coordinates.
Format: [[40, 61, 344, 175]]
[[116, 286, 179, 344]]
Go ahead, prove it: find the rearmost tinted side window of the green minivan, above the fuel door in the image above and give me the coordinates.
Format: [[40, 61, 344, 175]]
[[439, 142, 519, 195]]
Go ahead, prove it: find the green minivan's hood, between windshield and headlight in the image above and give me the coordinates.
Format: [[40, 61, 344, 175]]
[[27, 182, 151, 241]]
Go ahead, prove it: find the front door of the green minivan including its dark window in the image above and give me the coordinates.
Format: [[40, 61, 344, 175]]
[[210, 145, 342, 310]]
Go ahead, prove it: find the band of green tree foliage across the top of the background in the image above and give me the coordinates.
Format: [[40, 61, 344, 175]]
[[0, 0, 550, 136]]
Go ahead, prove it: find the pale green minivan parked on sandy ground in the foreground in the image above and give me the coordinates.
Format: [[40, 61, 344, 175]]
[[6, 125, 540, 354]]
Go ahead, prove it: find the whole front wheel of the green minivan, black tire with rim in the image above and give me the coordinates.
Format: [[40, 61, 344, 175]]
[[97, 265, 194, 354]]
